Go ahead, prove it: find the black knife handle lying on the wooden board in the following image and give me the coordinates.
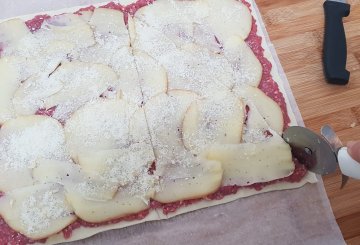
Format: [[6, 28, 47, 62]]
[[323, 1, 350, 85]]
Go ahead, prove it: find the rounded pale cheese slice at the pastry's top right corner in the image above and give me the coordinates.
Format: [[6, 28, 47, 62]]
[[206, 0, 252, 43]]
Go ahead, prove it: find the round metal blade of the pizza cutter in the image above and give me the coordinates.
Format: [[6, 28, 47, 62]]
[[283, 126, 338, 175]]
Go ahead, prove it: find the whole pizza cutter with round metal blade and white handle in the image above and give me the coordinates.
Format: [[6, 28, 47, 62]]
[[283, 125, 360, 188]]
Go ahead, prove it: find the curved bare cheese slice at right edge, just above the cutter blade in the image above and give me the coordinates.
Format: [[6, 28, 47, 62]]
[[233, 86, 284, 135]]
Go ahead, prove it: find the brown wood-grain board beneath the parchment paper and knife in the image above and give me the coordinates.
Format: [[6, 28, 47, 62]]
[[256, 0, 360, 245]]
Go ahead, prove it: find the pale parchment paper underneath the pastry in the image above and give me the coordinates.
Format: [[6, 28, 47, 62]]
[[0, 0, 345, 245]]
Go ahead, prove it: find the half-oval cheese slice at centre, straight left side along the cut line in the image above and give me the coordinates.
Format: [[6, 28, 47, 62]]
[[134, 50, 167, 103]]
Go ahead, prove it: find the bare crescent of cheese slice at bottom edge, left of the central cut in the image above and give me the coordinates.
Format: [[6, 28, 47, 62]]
[[66, 182, 154, 223]]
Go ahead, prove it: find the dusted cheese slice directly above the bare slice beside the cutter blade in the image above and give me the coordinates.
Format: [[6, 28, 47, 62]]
[[182, 92, 244, 154]]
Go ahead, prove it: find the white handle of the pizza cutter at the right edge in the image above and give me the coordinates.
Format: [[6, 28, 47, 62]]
[[338, 147, 360, 179]]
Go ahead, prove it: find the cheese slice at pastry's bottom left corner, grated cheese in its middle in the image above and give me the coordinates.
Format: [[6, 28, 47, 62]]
[[0, 184, 76, 240]]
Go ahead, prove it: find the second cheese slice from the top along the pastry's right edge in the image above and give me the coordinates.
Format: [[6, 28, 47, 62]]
[[224, 36, 263, 87]]
